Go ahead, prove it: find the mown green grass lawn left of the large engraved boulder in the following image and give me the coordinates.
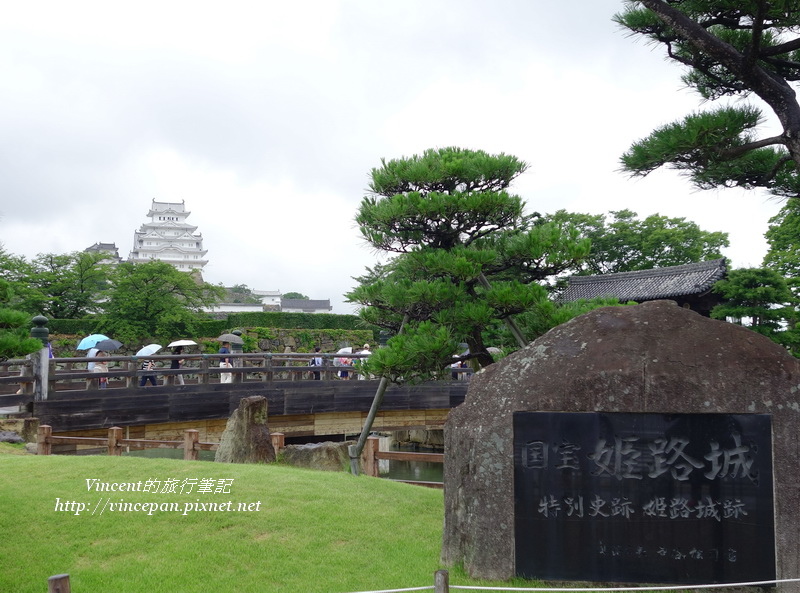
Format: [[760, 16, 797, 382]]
[[0, 447, 512, 593]]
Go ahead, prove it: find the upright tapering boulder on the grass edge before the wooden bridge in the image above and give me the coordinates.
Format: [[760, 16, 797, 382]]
[[214, 395, 275, 463]]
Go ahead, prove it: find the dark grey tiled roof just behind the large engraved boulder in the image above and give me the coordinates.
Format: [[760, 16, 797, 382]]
[[560, 258, 727, 302]]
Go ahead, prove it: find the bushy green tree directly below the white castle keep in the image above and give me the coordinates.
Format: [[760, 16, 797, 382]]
[[98, 260, 224, 343]]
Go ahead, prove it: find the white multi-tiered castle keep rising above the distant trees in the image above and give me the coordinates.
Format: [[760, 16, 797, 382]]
[[128, 199, 208, 272]]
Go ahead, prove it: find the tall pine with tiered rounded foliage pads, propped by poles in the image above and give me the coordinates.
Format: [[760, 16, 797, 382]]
[[347, 148, 589, 382]]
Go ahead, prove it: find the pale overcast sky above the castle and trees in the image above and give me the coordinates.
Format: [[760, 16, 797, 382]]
[[0, 0, 780, 313]]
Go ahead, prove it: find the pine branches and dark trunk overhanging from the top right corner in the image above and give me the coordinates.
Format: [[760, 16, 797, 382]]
[[614, 0, 800, 196]]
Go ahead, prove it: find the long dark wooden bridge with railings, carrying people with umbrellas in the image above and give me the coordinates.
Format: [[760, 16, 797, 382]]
[[0, 353, 468, 441]]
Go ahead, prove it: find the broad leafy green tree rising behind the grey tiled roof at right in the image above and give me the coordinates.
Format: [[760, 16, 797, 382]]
[[542, 210, 729, 274]]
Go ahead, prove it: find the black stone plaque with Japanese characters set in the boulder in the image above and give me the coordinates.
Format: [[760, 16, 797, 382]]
[[514, 412, 775, 584]]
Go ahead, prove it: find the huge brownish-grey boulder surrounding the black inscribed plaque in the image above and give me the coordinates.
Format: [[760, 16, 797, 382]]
[[442, 301, 800, 590]]
